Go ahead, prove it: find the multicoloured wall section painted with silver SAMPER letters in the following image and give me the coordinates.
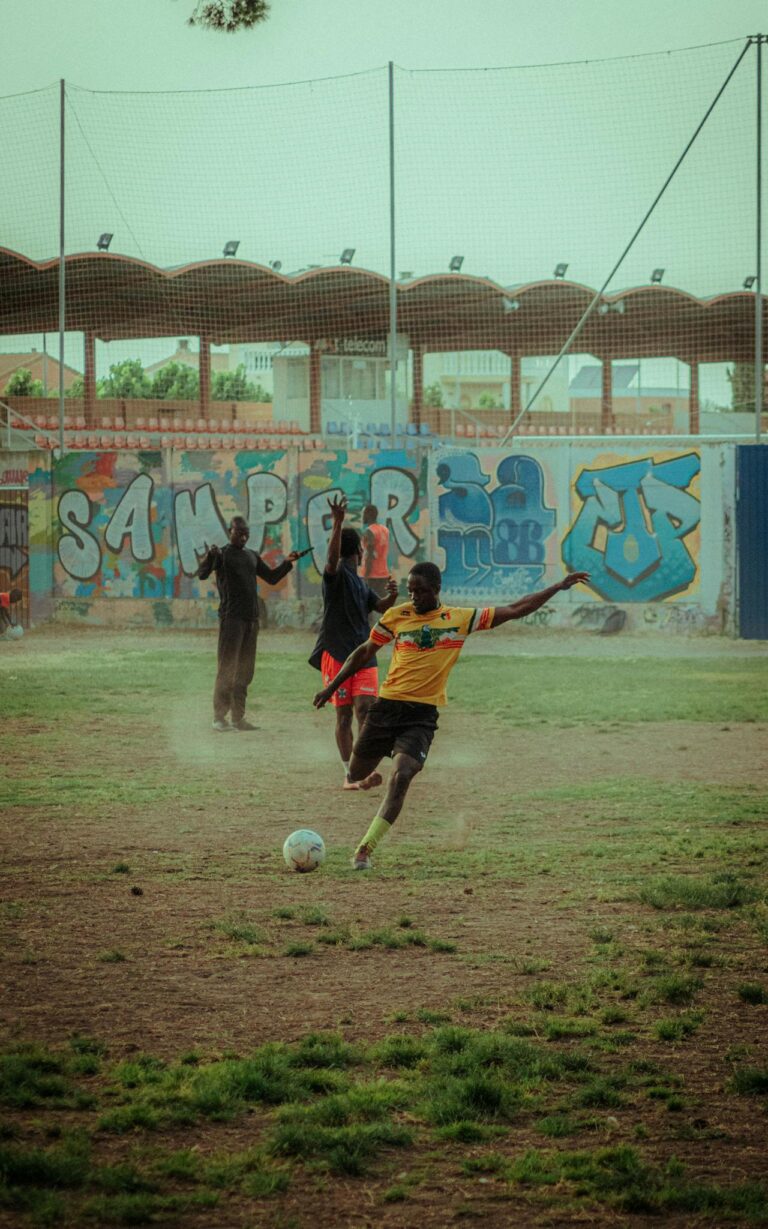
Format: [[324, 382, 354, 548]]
[[28, 449, 428, 626]]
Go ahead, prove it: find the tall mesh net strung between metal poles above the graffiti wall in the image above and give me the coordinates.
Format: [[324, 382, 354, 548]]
[[0, 42, 758, 449]]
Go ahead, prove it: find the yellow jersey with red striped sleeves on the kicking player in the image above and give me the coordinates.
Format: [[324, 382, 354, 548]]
[[371, 602, 495, 704]]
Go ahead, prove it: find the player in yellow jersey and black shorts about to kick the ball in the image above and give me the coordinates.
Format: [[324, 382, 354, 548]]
[[313, 563, 590, 870]]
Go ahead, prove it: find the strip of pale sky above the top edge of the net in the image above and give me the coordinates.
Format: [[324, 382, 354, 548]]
[[0, 0, 768, 95]]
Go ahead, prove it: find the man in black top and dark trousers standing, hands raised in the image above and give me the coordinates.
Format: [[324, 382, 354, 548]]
[[198, 516, 299, 734]]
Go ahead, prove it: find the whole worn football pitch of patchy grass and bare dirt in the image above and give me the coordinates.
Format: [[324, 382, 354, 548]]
[[0, 628, 768, 1229]]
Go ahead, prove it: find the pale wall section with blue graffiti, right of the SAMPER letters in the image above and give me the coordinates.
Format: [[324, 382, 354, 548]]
[[430, 442, 734, 630]]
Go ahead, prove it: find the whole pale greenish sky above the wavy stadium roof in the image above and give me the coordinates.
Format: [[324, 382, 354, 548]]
[[0, 0, 768, 395]]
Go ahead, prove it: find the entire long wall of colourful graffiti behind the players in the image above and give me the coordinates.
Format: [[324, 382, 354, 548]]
[[20, 441, 734, 630]]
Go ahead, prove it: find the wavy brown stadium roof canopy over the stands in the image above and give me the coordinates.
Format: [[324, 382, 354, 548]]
[[0, 248, 754, 363]]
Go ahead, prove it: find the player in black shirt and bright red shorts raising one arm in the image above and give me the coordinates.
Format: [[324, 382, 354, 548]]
[[310, 497, 397, 789]]
